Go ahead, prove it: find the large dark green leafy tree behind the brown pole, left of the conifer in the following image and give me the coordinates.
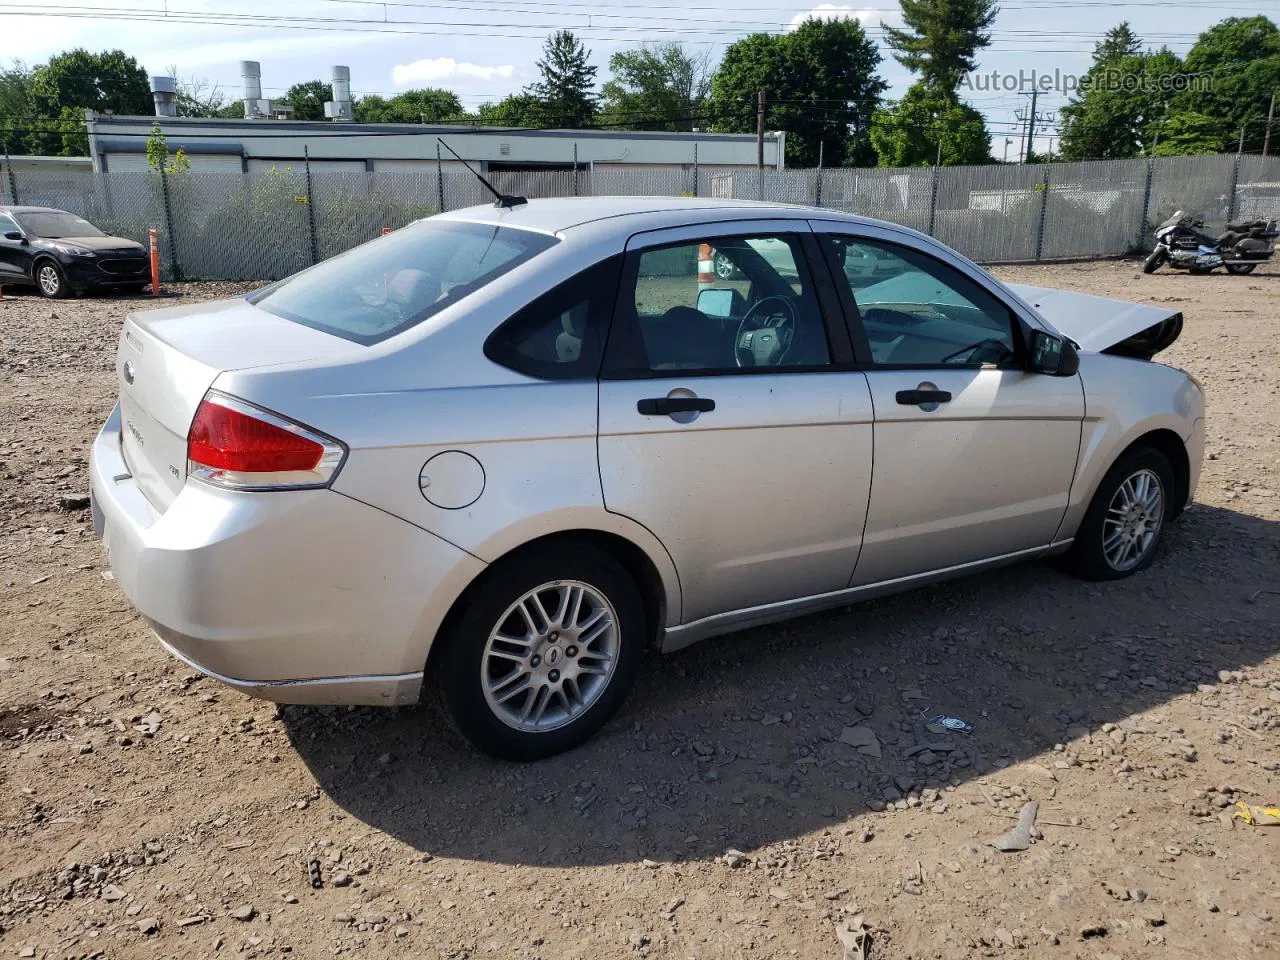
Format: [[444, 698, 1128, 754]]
[[708, 18, 886, 166]]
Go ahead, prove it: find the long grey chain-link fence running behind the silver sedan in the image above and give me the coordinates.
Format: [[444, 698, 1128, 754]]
[[0, 150, 1280, 280]]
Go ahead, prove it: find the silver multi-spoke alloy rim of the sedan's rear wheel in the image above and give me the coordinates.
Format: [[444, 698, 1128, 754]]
[[480, 580, 620, 733]]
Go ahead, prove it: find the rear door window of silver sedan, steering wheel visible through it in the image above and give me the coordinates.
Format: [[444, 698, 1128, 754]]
[[622, 236, 831, 374]]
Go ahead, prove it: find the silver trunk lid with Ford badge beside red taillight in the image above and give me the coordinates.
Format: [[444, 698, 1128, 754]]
[[115, 300, 364, 511]]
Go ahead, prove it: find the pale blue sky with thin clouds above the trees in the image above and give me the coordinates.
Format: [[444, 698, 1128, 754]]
[[0, 0, 1280, 157]]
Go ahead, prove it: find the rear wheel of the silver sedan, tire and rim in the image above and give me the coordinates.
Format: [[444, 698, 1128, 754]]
[[434, 544, 648, 760]]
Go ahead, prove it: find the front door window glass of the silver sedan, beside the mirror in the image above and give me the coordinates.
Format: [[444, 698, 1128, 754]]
[[822, 237, 1019, 366]]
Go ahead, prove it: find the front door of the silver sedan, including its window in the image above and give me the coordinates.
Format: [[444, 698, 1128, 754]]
[[814, 223, 1084, 585]]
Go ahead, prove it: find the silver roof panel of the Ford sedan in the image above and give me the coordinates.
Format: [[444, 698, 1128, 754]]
[[439, 196, 914, 241]]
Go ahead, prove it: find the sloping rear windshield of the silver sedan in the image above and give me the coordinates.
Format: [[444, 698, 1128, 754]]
[[250, 220, 557, 344]]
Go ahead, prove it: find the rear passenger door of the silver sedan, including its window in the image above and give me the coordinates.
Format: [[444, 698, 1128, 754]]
[[599, 220, 872, 623]]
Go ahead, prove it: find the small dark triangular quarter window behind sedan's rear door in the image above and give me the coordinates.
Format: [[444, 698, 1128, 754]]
[[484, 256, 622, 380]]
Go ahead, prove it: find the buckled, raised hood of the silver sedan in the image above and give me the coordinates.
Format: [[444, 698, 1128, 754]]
[[1007, 283, 1183, 360]]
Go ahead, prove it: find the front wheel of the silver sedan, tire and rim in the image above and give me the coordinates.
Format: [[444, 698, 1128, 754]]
[[1066, 447, 1174, 580]]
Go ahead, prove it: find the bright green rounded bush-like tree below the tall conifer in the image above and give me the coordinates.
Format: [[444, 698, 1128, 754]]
[[870, 79, 992, 166]]
